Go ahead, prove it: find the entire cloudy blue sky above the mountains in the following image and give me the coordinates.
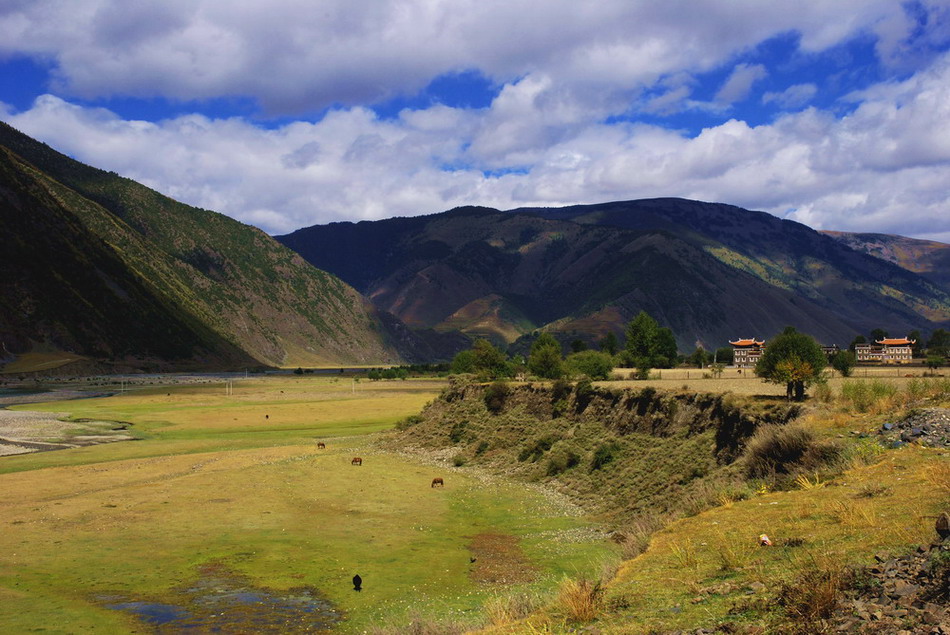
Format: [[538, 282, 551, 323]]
[[0, 0, 950, 242]]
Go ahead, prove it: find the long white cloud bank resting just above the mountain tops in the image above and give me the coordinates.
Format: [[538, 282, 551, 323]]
[[9, 47, 950, 239]]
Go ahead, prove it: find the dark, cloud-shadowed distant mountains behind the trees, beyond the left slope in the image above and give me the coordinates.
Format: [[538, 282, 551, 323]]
[[277, 198, 950, 351]]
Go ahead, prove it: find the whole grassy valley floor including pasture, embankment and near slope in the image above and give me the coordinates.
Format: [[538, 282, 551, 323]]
[[0, 369, 950, 633]]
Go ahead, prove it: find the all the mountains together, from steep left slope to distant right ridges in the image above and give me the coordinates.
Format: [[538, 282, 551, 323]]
[[0, 123, 950, 369]]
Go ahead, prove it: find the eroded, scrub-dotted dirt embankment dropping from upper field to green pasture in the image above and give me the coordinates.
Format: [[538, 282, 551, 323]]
[[397, 381, 799, 524]]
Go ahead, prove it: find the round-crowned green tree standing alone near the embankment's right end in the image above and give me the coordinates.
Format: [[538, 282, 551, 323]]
[[755, 326, 827, 401]]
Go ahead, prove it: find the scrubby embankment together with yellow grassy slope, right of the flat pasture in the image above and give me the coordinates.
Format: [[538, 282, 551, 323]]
[[394, 379, 950, 634]]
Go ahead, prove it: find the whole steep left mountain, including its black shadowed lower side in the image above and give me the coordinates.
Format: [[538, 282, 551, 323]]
[[0, 124, 434, 368]]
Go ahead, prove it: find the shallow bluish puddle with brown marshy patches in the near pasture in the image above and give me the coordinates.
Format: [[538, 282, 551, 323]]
[[95, 564, 342, 633]]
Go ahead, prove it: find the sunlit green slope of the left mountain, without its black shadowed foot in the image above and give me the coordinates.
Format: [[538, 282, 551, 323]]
[[0, 123, 399, 366]]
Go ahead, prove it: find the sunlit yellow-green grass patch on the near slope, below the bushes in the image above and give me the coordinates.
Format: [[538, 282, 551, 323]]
[[601, 448, 950, 632]]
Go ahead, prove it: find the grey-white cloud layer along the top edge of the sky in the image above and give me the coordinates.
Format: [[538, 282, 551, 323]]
[[0, 0, 932, 114]]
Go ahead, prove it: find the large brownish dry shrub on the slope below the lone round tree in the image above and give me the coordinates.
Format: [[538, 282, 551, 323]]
[[745, 425, 841, 478]]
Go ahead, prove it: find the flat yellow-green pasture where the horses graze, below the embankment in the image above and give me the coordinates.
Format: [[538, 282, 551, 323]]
[[0, 377, 615, 633]]
